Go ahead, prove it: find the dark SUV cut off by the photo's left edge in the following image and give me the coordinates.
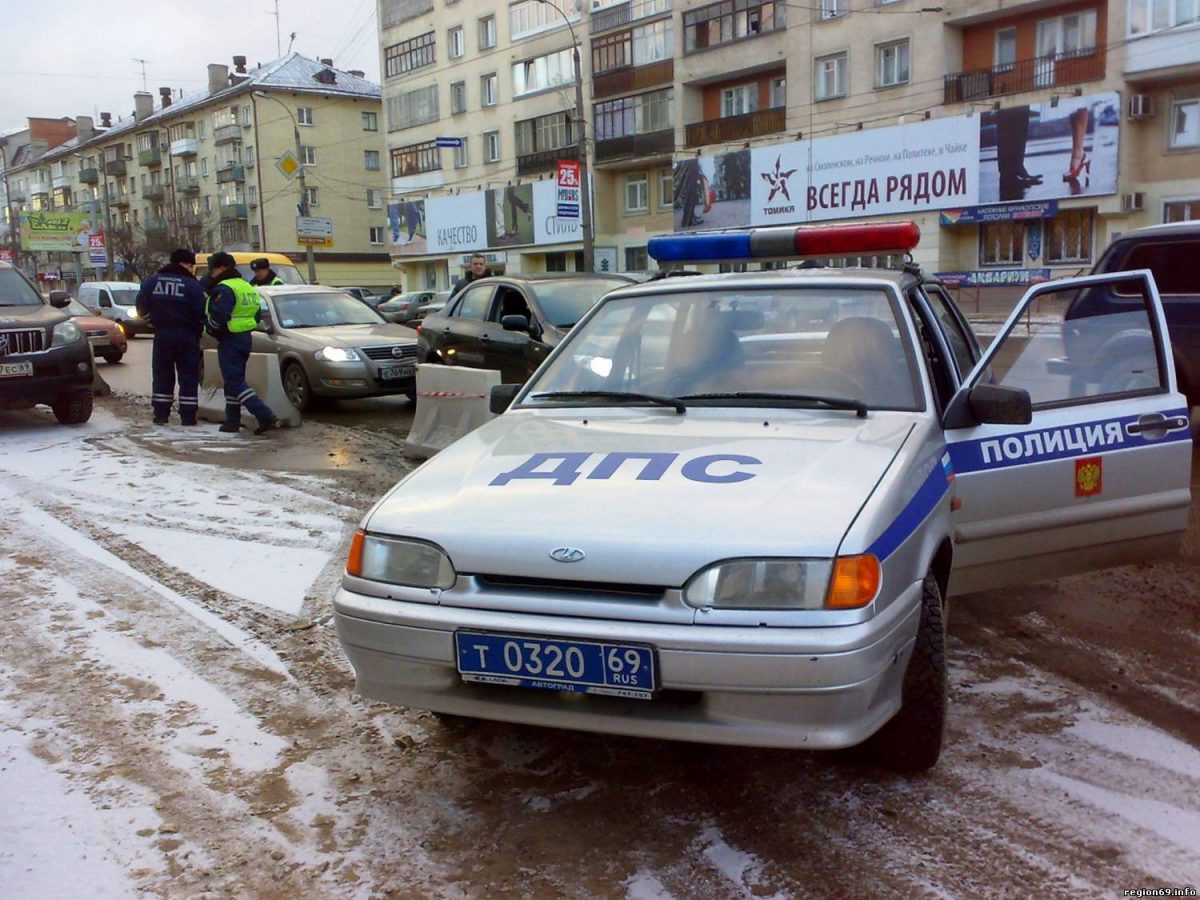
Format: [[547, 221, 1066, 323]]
[[0, 263, 92, 425]]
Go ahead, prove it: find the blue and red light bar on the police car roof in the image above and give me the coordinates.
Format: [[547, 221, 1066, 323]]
[[647, 222, 920, 263]]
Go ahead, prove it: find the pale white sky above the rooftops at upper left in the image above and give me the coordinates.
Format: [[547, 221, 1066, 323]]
[[0, 0, 379, 134]]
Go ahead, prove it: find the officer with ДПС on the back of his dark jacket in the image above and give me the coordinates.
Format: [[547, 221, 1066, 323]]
[[137, 247, 204, 425]]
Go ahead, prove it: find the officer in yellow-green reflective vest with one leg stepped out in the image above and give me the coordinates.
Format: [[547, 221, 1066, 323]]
[[206, 252, 278, 434]]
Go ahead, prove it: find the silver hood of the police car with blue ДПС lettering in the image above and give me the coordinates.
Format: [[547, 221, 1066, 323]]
[[365, 409, 913, 586]]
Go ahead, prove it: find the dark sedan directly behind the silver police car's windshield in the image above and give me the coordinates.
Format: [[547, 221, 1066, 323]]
[[418, 272, 632, 383]]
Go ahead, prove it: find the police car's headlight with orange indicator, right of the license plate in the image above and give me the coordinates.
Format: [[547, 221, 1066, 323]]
[[683, 554, 880, 610]]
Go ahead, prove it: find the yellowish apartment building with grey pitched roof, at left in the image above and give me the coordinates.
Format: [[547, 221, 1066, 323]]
[[5, 53, 395, 286]]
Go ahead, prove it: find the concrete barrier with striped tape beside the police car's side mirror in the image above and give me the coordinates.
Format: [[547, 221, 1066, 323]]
[[404, 362, 500, 458]]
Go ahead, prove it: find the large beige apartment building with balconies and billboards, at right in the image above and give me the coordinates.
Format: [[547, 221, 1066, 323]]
[[379, 0, 1200, 287]]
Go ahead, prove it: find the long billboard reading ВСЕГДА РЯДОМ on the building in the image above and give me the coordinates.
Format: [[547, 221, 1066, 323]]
[[674, 92, 1121, 232]]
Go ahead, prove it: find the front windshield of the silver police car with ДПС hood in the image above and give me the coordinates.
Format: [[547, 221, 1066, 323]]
[[523, 286, 922, 409]]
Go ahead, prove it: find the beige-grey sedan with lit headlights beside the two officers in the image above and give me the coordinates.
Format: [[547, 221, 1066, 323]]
[[251, 284, 416, 412]]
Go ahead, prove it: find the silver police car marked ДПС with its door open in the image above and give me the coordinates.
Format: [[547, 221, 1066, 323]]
[[335, 223, 1192, 770]]
